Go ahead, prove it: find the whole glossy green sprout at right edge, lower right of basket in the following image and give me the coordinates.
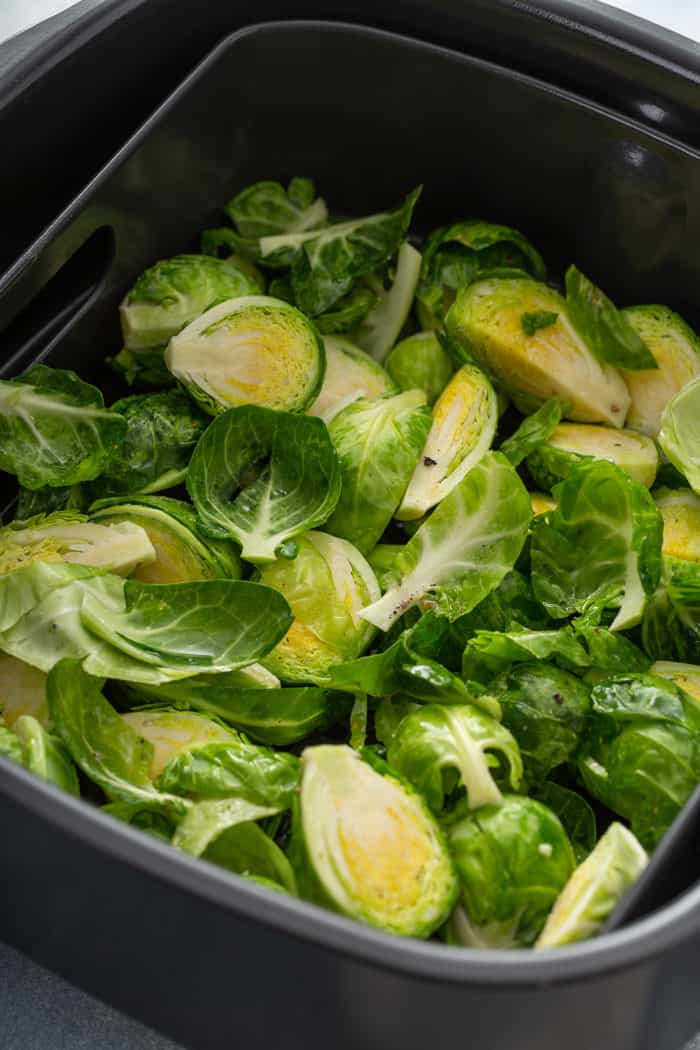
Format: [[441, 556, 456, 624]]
[[578, 674, 700, 848]]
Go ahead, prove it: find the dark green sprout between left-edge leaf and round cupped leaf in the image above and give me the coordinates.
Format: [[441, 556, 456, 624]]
[[89, 391, 210, 500]]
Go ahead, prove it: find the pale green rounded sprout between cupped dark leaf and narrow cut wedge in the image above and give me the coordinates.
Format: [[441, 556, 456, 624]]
[[325, 391, 430, 554]]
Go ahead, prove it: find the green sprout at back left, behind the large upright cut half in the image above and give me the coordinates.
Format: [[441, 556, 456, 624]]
[[120, 255, 258, 351]]
